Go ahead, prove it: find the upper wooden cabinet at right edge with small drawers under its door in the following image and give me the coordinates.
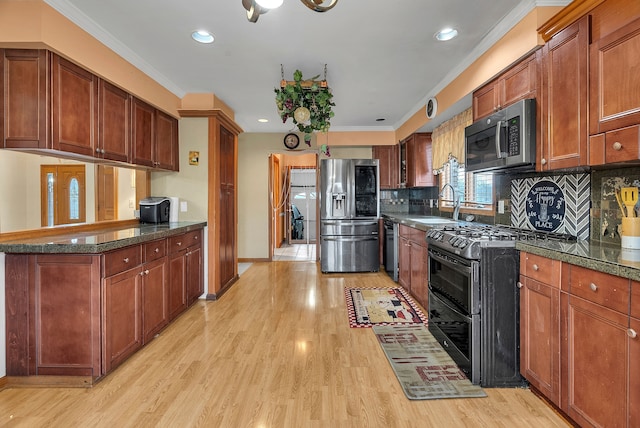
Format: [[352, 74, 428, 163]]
[[589, 18, 640, 165]]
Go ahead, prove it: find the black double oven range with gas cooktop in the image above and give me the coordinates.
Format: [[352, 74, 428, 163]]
[[427, 224, 575, 387]]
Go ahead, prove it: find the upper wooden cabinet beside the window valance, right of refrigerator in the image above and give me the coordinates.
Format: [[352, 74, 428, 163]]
[[399, 132, 437, 187]]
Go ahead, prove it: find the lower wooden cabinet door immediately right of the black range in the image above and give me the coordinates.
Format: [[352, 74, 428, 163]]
[[518, 276, 560, 406]]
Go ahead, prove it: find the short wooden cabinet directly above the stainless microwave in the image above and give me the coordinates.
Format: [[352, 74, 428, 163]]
[[472, 52, 539, 121]]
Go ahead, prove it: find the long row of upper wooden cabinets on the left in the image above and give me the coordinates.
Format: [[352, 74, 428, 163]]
[[0, 49, 179, 170]]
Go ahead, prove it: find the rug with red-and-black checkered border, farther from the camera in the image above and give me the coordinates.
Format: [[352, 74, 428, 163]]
[[344, 287, 427, 327]]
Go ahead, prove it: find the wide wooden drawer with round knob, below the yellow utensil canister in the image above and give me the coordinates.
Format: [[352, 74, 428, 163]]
[[569, 266, 629, 314]]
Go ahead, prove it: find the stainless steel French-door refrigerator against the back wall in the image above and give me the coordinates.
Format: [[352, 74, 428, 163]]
[[319, 159, 380, 272]]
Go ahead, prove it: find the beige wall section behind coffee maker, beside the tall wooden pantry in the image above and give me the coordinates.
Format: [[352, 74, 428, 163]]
[[151, 118, 209, 221]]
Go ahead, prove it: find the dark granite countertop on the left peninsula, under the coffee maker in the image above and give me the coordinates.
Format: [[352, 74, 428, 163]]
[[0, 221, 207, 254]]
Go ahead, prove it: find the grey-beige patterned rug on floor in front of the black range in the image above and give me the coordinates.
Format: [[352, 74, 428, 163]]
[[373, 324, 487, 400]]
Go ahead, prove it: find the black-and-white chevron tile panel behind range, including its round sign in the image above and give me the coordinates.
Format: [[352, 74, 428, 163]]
[[511, 174, 591, 239]]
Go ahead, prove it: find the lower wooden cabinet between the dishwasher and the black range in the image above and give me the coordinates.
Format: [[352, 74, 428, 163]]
[[398, 224, 429, 309]]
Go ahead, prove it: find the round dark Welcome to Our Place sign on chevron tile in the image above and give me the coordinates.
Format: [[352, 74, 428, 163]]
[[526, 180, 566, 232]]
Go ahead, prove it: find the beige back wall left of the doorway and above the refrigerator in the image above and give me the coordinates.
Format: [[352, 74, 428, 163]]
[[238, 133, 371, 259]]
